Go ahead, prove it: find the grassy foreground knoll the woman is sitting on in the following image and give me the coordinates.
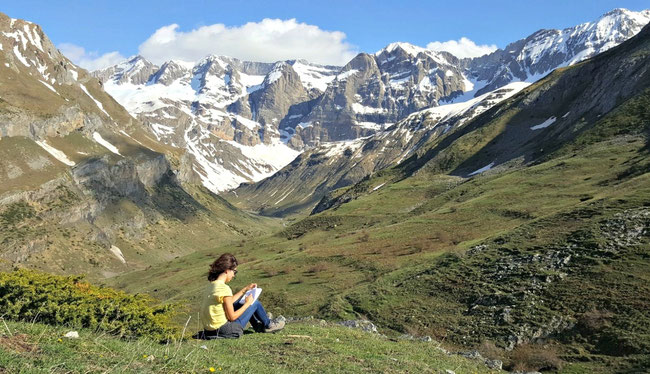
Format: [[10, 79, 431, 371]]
[[0, 322, 497, 373]]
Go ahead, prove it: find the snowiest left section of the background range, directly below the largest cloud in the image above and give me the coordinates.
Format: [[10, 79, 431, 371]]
[[94, 56, 339, 192]]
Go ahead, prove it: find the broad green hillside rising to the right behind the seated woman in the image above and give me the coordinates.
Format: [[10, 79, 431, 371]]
[[113, 79, 650, 370]]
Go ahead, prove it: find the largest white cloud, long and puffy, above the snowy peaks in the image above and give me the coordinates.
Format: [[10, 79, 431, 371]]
[[140, 18, 356, 65]]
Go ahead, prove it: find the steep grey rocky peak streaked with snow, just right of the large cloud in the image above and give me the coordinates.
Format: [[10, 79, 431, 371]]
[[296, 43, 465, 144]]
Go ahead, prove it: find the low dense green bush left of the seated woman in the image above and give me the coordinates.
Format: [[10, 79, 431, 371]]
[[0, 269, 178, 340]]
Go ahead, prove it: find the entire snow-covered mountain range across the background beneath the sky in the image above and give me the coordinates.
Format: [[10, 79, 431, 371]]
[[94, 9, 650, 192]]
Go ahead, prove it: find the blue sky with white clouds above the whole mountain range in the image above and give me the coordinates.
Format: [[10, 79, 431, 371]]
[[0, 0, 650, 67]]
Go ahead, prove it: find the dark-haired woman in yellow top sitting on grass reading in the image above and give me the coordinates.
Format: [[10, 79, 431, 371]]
[[198, 253, 284, 339]]
